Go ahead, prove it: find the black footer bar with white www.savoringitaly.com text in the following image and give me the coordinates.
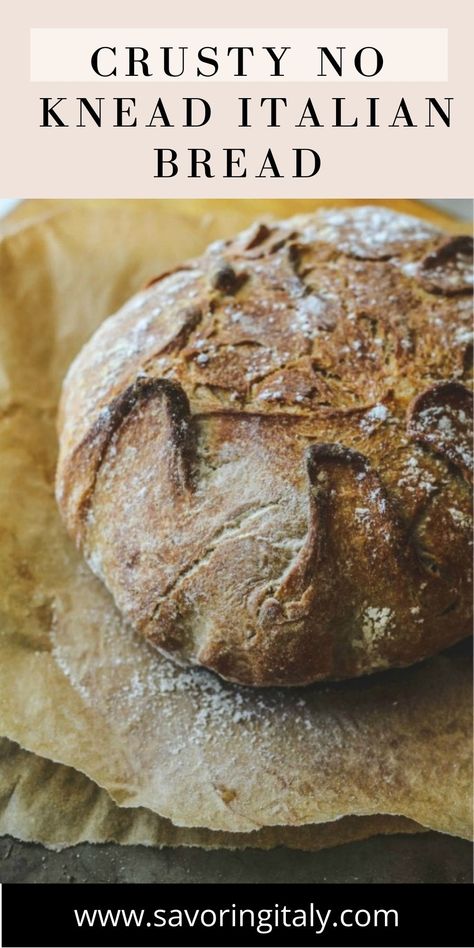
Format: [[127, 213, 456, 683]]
[[2, 884, 472, 948]]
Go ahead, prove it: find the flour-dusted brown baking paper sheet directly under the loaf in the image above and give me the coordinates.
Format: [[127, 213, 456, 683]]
[[0, 201, 472, 836]]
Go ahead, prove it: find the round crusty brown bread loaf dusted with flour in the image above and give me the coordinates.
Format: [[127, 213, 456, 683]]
[[57, 207, 472, 685]]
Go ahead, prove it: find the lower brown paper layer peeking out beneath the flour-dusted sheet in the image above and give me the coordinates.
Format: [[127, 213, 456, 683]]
[[0, 738, 423, 851]]
